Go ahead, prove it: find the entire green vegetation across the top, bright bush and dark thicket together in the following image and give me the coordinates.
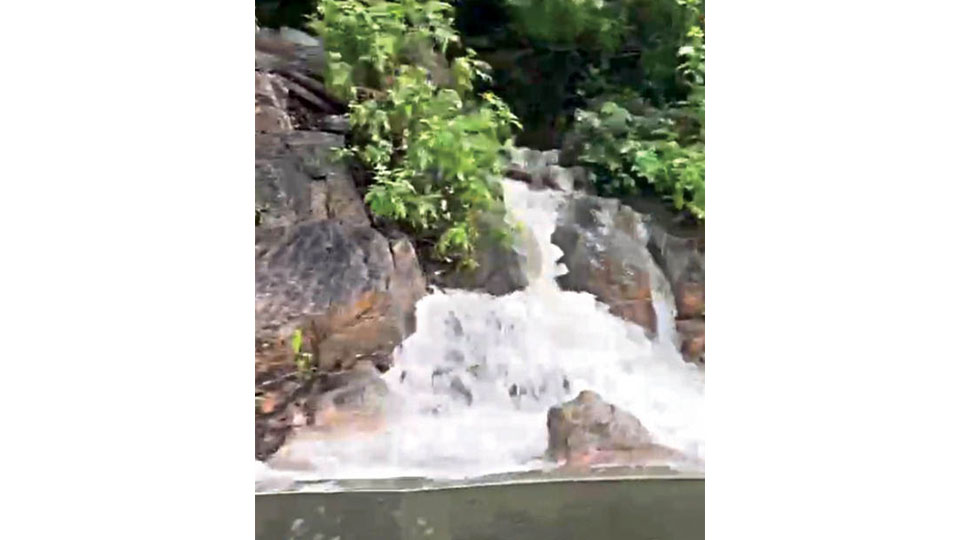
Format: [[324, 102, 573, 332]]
[[258, 0, 705, 265]]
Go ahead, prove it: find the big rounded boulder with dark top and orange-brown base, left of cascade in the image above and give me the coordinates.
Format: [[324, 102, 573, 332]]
[[256, 220, 426, 371]]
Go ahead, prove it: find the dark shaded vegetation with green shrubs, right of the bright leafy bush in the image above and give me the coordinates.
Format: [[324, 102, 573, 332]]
[[461, 0, 705, 219]]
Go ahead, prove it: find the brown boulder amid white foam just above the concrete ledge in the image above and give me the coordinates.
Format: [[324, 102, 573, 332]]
[[547, 391, 686, 465]]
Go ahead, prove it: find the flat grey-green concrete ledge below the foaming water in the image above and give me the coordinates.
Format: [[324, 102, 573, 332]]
[[256, 476, 704, 540]]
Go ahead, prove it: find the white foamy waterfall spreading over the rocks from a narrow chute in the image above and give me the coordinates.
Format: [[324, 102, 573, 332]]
[[266, 181, 704, 479]]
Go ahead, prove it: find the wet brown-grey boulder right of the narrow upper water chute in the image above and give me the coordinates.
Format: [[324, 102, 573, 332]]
[[552, 194, 672, 336]]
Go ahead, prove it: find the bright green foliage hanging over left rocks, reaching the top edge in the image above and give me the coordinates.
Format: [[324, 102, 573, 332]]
[[314, 0, 520, 266]]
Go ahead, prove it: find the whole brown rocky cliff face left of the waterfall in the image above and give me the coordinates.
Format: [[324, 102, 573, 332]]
[[255, 32, 426, 459]]
